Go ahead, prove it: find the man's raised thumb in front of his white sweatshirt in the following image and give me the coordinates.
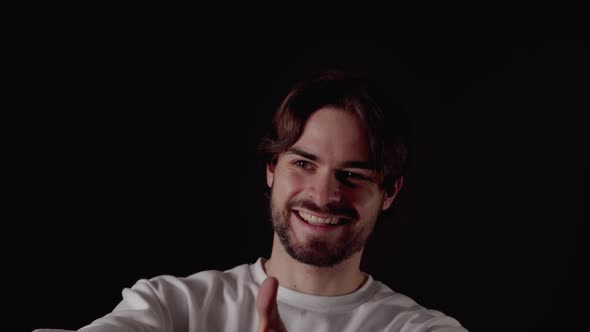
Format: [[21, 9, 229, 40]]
[[256, 277, 287, 332]]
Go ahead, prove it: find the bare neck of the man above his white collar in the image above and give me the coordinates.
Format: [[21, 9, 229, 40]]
[[263, 234, 366, 296]]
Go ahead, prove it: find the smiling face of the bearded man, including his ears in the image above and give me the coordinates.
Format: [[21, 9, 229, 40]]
[[266, 107, 401, 266]]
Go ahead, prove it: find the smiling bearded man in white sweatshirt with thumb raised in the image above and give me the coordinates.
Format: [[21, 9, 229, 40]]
[[34, 70, 466, 332]]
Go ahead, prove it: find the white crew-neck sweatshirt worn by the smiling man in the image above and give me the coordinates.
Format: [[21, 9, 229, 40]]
[[38, 258, 467, 332]]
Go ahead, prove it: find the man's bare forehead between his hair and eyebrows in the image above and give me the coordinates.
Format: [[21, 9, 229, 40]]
[[293, 107, 369, 162]]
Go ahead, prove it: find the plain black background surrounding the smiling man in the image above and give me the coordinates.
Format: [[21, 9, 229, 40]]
[[0, 4, 590, 331]]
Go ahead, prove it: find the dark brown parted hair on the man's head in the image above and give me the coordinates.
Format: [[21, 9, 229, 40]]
[[259, 71, 410, 195]]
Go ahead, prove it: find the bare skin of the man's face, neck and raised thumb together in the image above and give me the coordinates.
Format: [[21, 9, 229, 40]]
[[257, 107, 403, 331]]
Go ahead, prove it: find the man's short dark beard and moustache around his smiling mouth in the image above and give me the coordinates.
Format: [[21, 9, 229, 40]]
[[270, 188, 379, 267]]
